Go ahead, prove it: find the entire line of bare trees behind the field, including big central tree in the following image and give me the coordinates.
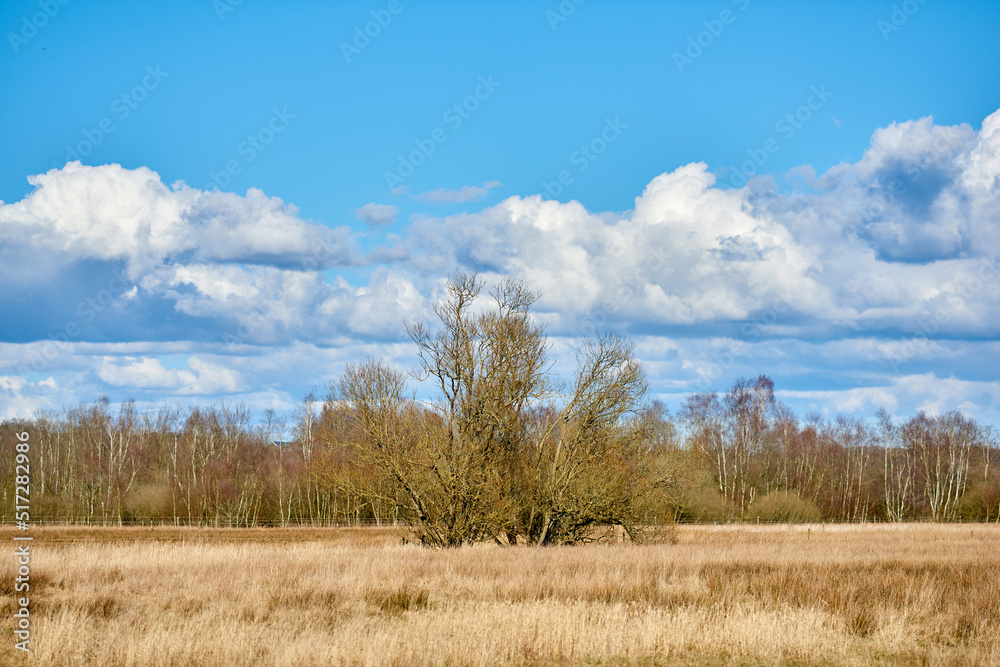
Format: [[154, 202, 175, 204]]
[[0, 275, 1000, 545]]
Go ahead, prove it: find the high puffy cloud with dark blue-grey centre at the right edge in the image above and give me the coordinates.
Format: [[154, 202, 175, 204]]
[[776, 112, 1000, 264]]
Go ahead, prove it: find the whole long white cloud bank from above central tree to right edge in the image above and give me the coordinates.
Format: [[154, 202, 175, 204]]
[[411, 112, 1000, 337]]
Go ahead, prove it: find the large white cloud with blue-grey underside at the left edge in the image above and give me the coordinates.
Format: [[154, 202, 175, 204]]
[[0, 162, 398, 350]]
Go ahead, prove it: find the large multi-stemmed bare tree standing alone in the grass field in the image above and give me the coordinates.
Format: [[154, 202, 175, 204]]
[[328, 275, 660, 546]]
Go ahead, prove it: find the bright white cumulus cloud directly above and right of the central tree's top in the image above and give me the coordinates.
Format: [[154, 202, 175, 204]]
[[414, 164, 832, 332]]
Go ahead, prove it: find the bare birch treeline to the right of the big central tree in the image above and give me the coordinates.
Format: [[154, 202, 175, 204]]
[[675, 376, 1000, 521]]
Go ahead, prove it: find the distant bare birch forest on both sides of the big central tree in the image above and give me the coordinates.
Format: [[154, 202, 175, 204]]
[[0, 376, 1000, 526]]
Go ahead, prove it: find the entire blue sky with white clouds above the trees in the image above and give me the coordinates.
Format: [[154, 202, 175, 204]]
[[0, 0, 1000, 423]]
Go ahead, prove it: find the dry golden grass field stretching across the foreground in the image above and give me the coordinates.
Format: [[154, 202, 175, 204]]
[[0, 524, 1000, 665]]
